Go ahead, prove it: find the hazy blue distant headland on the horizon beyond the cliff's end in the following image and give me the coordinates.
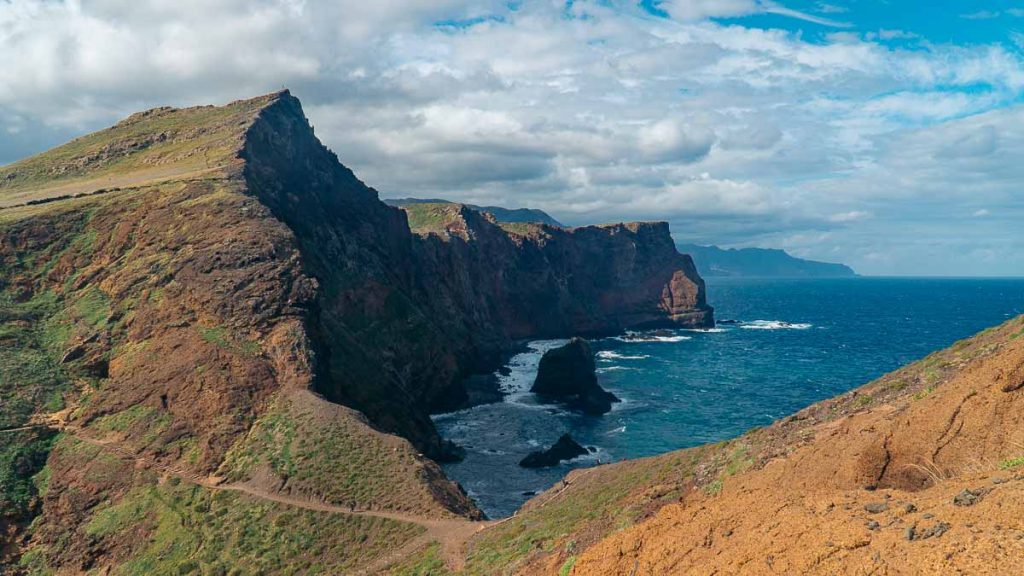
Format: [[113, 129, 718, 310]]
[[676, 244, 857, 278]]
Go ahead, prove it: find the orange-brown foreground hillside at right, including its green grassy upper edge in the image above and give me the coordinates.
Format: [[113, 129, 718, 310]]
[[456, 317, 1024, 575]]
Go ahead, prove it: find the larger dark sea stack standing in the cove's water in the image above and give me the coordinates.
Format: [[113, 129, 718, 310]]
[[530, 338, 618, 416]]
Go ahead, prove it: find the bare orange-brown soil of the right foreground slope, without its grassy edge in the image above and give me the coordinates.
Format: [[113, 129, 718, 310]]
[[565, 320, 1024, 576]]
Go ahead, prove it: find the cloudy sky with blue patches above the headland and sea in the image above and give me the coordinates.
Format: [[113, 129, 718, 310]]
[[0, 0, 1024, 276]]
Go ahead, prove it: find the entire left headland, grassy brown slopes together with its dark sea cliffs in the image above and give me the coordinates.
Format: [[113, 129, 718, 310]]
[[0, 91, 713, 573]]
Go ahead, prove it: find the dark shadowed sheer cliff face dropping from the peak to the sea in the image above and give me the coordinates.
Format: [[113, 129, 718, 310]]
[[234, 94, 714, 458]]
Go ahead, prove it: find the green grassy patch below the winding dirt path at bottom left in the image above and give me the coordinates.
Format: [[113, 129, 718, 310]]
[[75, 483, 423, 575]]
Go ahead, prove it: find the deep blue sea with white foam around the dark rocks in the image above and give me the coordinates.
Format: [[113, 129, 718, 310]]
[[435, 278, 1024, 518]]
